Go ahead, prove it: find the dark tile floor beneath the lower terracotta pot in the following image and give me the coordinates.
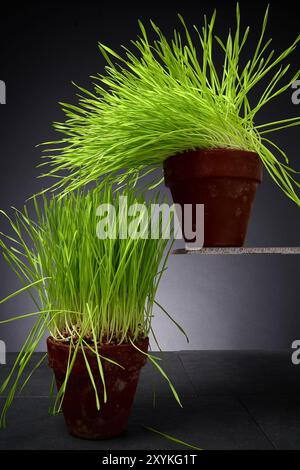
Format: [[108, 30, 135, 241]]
[[0, 351, 300, 450]]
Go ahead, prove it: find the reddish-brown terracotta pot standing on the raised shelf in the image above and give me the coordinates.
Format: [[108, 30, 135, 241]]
[[164, 149, 263, 247]]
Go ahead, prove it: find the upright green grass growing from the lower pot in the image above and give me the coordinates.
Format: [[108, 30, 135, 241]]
[[0, 183, 184, 424]]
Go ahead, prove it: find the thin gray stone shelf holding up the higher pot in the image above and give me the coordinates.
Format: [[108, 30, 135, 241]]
[[173, 246, 300, 255]]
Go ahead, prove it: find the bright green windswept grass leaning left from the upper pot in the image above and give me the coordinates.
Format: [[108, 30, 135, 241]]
[[42, 4, 300, 205]]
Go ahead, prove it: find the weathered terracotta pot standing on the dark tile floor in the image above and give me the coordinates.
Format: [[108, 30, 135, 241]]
[[47, 337, 149, 439]]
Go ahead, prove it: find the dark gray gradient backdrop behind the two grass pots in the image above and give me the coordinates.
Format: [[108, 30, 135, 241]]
[[0, 1, 300, 351]]
